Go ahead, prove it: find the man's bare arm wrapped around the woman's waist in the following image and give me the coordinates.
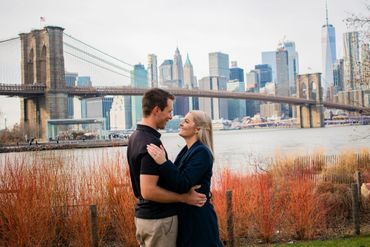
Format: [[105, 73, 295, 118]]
[[140, 174, 207, 207]]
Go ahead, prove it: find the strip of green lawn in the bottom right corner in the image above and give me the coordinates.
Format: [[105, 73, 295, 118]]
[[272, 235, 370, 247]]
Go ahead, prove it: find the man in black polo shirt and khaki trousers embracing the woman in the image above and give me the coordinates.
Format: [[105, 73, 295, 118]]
[[127, 88, 207, 247]]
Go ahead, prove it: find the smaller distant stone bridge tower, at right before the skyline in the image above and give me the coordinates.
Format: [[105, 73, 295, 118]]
[[296, 73, 324, 128]]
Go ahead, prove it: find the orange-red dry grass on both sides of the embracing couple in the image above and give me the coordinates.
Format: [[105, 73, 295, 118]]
[[0, 150, 370, 246]]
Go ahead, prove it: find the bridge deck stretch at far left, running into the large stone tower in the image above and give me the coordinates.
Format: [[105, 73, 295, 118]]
[[0, 83, 46, 96]]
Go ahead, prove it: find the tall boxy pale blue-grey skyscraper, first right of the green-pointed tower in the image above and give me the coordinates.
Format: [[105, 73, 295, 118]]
[[208, 52, 230, 81]]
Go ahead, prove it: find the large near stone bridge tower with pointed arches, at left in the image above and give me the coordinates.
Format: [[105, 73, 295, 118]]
[[19, 26, 67, 140]]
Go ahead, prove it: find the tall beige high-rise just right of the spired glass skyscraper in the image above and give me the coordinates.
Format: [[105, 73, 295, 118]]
[[343, 32, 361, 90]]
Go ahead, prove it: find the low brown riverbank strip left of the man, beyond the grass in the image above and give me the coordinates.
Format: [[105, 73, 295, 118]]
[[0, 139, 128, 153]]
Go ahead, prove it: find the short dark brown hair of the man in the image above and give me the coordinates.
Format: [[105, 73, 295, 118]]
[[142, 88, 175, 117]]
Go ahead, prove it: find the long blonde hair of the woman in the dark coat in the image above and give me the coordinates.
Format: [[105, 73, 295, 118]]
[[190, 110, 214, 160]]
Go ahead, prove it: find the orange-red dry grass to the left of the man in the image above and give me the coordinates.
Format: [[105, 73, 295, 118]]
[[0, 150, 136, 246]]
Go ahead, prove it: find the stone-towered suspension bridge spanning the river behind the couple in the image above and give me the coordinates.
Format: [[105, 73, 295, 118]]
[[0, 26, 370, 139]]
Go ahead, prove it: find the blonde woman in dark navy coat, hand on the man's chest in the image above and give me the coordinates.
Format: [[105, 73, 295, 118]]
[[147, 111, 223, 247]]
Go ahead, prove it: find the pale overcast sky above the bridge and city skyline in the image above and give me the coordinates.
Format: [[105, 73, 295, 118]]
[[0, 0, 369, 129]]
